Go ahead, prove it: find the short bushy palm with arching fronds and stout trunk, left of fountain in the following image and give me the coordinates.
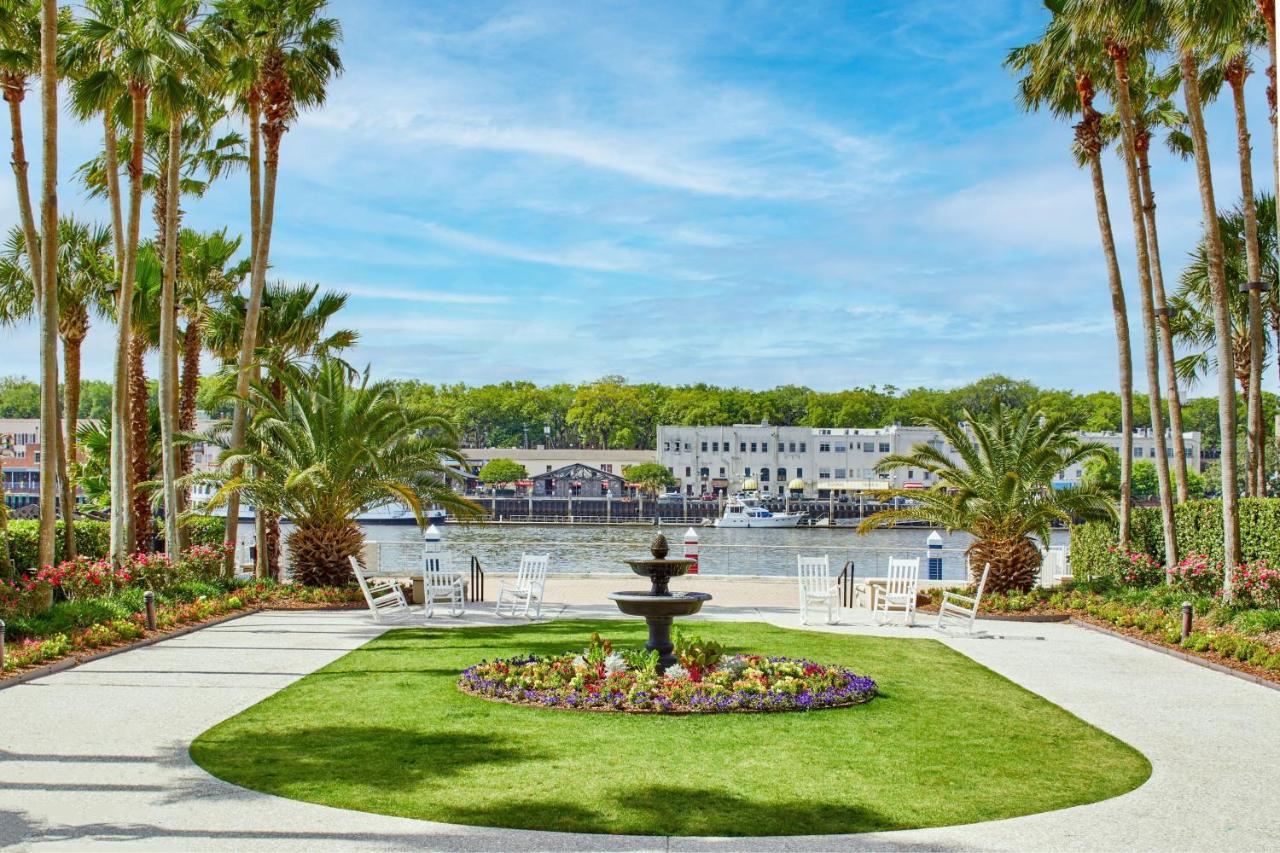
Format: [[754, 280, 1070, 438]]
[[188, 359, 481, 585]]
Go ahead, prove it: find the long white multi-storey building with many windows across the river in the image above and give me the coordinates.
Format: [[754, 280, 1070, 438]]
[[657, 423, 1201, 498]]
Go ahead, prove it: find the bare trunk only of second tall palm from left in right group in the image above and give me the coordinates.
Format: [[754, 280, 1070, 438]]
[[1107, 42, 1178, 569]]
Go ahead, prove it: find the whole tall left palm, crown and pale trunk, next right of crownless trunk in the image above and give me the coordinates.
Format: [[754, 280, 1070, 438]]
[[73, 0, 186, 561]]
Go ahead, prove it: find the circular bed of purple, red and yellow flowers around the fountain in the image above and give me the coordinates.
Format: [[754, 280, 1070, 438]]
[[458, 638, 876, 713]]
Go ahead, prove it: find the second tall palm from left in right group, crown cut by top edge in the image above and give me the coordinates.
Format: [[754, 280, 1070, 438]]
[[1064, 0, 1178, 567]]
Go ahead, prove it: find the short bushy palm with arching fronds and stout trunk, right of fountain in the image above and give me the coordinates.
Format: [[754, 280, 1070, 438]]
[[858, 403, 1116, 592]]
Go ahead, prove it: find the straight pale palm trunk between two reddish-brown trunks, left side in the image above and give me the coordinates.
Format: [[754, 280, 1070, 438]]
[[159, 110, 182, 560]]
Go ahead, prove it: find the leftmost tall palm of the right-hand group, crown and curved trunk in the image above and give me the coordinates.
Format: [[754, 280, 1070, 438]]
[[1005, 0, 1133, 547]]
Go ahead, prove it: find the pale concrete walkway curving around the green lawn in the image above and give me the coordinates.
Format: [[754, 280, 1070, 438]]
[[0, 594, 1280, 852]]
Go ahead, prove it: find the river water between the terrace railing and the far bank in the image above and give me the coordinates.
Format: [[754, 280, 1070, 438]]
[[241, 524, 1069, 580]]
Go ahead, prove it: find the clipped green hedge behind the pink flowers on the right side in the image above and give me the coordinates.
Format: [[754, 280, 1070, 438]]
[[1071, 498, 1280, 575]]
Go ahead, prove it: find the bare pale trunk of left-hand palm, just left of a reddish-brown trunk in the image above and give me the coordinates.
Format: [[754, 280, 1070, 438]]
[[111, 86, 147, 565]]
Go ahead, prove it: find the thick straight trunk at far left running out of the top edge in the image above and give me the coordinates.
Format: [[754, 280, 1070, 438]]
[[36, 0, 59, 566]]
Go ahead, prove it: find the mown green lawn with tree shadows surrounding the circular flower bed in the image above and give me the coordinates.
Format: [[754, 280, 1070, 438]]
[[191, 621, 1151, 835]]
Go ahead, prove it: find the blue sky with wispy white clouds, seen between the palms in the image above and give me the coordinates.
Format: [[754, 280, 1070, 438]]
[[0, 0, 1271, 391]]
